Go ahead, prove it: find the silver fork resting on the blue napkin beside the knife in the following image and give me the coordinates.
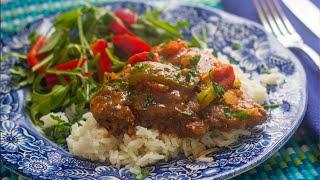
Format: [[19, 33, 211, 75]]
[[253, 0, 320, 69]]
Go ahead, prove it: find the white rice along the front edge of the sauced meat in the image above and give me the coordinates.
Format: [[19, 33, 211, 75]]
[[67, 112, 249, 173]]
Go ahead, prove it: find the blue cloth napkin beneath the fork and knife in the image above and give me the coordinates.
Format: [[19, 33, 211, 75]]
[[222, 0, 320, 142]]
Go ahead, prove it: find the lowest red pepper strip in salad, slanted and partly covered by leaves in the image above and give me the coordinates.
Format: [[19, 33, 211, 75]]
[[45, 59, 86, 89]]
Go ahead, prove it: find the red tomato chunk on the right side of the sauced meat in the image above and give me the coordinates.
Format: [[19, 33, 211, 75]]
[[212, 64, 235, 89]]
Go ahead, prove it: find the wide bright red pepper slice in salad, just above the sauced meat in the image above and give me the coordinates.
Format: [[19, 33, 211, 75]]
[[112, 34, 151, 56]]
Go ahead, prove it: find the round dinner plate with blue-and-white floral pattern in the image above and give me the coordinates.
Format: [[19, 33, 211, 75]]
[[0, 2, 307, 179]]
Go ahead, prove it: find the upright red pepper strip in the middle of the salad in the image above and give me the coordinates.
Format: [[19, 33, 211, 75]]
[[91, 39, 112, 82]]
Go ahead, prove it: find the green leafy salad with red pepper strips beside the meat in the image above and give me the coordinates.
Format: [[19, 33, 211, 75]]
[[2, 5, 206, 144]]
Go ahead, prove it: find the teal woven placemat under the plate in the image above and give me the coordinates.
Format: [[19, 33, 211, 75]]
[[0, 0, 320, 179]]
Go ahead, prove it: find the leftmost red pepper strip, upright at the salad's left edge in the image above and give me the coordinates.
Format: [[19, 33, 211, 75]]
[[27, 35, 47, 73]]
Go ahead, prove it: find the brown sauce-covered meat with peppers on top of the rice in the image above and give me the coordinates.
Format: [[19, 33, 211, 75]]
[[90, 40, 267, 137]]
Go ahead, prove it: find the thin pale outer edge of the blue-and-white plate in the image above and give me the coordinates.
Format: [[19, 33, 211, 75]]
[[1, 0, 308, 179]]
